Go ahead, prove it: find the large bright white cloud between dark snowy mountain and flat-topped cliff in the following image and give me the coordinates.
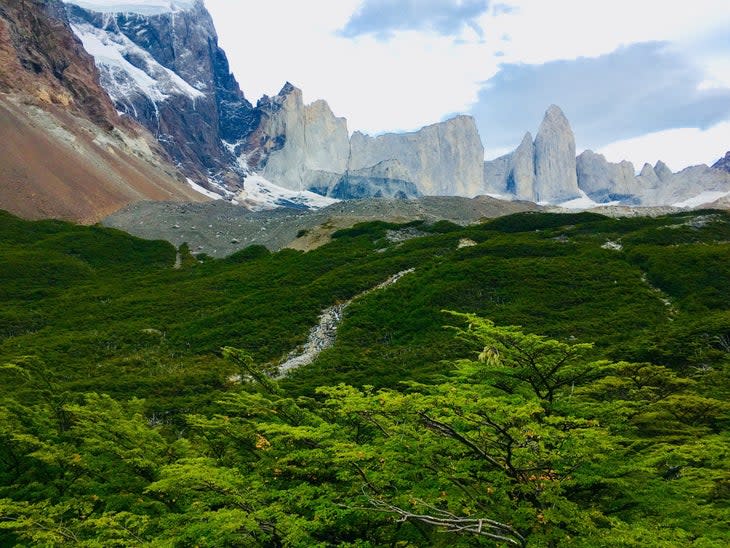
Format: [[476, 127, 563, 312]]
[[206, 0, 497, 133]]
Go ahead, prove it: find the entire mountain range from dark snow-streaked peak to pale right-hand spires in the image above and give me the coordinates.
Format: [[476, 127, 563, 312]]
[[61, 0, 730, 207]]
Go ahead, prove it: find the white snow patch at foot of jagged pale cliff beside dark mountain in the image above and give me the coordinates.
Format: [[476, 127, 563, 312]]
[[236, 173, 339, 211]]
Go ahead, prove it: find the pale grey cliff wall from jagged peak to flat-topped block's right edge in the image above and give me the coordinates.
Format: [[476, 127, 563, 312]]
[[246, 83, 484, 198]]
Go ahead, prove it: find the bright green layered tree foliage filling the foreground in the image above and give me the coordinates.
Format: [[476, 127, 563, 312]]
[[0, 314, 730, 546]]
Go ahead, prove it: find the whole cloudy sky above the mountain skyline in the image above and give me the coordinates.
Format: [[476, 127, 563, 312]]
[[198, 0, 730, 171]]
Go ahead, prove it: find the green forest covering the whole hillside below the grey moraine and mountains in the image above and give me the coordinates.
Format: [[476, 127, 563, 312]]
[[0, 210, 730, 548]]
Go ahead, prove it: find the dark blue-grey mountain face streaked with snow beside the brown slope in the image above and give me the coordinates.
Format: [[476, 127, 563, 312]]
[[67, 0, 259, 191]]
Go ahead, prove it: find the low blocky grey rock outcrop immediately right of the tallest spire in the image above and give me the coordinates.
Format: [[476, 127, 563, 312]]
[[576, 150, 636, 205]]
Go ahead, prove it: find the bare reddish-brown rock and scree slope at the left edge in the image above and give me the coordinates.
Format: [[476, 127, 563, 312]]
[[0, 0, 205, 223]]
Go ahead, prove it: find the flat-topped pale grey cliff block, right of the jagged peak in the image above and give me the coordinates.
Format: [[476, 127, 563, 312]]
[[349, 116, 484, 196]]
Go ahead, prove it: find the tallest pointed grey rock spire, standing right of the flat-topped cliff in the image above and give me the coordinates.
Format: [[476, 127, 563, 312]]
[[535, 105, 580, 203]]
